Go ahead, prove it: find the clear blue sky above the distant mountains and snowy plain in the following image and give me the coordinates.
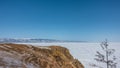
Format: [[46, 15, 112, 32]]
[[0, 0, 120, 42]]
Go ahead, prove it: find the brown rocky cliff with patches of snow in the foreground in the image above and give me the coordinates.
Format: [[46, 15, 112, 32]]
[[0, 44, 84, 68]]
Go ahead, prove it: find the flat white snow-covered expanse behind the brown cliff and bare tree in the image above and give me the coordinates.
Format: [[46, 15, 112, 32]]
[[17, 43, 120, 68]]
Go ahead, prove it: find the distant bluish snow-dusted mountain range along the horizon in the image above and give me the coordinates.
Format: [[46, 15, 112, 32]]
[[0, 38, 85, 43]]
